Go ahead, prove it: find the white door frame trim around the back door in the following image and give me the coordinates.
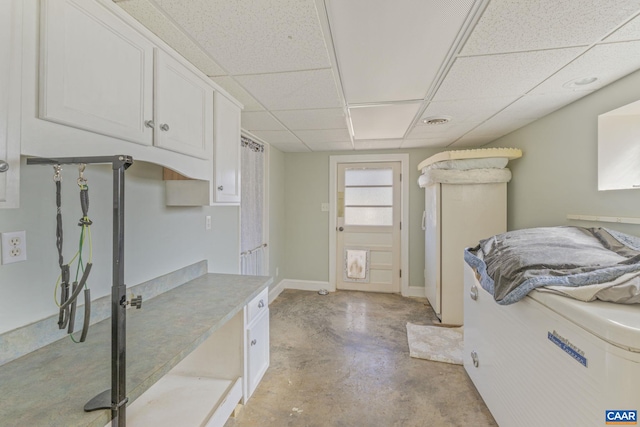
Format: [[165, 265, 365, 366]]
[[329, 153, 410, 296]]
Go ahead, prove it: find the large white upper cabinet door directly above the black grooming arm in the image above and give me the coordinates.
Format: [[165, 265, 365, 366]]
[[40, 0, 153, 145]]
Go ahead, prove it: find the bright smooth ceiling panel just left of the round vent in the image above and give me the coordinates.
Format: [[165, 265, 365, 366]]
[[349, 102, 421, 139]]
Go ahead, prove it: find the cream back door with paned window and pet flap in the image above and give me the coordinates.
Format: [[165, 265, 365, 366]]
[[336, 162, 401, 292]]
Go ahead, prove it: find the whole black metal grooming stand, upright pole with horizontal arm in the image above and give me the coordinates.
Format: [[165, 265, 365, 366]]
[[27, 155, 134, 427]]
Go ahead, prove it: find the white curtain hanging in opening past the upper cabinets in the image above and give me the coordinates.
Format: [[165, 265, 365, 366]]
[[240, 136, 266, 275]]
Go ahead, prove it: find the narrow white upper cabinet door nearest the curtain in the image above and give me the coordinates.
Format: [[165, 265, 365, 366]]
[[213, 92, 240, 203]]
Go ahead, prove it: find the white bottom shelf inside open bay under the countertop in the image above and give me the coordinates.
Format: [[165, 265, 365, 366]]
[[127, 373, 242, 427]]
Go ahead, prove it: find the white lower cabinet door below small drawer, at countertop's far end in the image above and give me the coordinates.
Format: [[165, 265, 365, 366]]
[[245, 309, 269, 402]]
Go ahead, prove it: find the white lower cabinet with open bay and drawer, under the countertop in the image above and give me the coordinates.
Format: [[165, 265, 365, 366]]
[[127, 288, 269, 427]]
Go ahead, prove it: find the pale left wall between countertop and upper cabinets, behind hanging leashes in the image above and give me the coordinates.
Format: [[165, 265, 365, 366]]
[[0, 159, 239, 333]]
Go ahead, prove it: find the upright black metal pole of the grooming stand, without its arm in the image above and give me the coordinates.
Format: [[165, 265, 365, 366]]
[[111, 160, 128, 427]]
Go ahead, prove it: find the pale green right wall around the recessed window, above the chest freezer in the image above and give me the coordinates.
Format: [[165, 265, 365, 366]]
[[490, 68, 640, 235]]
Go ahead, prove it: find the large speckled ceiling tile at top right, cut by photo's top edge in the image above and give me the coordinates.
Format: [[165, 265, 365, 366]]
[[462, 0, 640, 55]]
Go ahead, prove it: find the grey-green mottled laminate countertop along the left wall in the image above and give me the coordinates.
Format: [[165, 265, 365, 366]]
[[0, 274, 272, 427]]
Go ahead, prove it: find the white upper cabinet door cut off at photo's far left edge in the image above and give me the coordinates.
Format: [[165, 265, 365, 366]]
[[0, 0, 22, 208]]
